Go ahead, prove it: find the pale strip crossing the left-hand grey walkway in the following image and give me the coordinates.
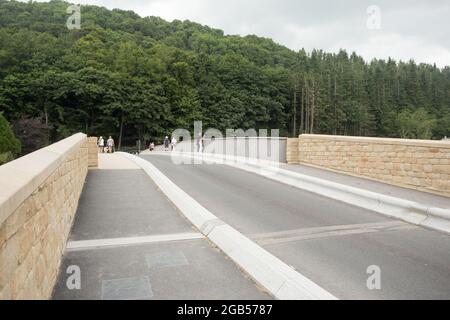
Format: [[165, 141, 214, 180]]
[[66, 232, 204, 251]]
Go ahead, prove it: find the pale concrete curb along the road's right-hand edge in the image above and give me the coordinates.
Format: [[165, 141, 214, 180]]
[[147, 152, 450, 234]]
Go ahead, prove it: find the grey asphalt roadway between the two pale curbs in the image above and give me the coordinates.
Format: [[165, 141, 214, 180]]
[[142, 155, 450, 299]]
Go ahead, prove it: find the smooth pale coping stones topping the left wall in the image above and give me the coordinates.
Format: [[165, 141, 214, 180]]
[[0, 133, 86, 225]]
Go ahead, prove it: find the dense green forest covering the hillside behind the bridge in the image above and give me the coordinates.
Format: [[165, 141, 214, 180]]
[[0, 0, 450, 152]]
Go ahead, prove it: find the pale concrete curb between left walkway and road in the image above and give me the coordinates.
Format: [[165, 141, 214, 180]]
[[120, 153, 337, 300]]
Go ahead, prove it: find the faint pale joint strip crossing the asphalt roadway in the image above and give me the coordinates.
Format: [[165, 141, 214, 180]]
[[251, 221, 418, 245]]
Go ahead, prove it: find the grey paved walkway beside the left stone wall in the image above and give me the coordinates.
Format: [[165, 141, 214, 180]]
[[53, 154, 271, 300]]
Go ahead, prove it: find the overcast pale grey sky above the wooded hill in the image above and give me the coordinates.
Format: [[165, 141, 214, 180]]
[[39, 0, 450, 67]]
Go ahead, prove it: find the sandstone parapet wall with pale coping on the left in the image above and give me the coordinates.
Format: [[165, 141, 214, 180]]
[[0, 134, 88, 300]]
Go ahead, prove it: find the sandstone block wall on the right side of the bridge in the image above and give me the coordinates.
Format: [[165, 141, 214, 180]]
[[293, 135, 450, 196]]
